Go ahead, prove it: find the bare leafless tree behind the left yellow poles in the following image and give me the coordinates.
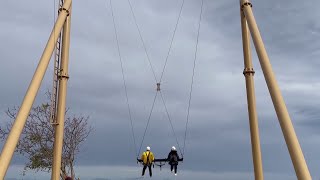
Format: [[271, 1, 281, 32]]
[[0, 95, 93, 179]]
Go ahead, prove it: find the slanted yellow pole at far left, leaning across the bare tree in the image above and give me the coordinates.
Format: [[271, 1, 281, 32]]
[[0, 0, 71, 179]]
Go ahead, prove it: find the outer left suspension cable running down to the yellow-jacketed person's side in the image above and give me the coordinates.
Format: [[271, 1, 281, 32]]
[[109, 0, 139, 157]]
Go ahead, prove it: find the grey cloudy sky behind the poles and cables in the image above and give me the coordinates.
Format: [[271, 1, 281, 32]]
[[0, 0, 320, 180]]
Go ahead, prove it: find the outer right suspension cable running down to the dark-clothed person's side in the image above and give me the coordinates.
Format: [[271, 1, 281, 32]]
[[182, 0, 203, 156]]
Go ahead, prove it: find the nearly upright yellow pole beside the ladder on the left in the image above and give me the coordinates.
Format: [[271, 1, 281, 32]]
[[51, 3, 71, 180]]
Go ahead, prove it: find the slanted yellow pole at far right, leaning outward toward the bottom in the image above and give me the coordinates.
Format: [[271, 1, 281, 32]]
[[240, 0, 311, 180]]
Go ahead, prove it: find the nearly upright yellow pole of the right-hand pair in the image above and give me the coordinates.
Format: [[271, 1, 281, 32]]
[[240, 4, 263, 180]]
